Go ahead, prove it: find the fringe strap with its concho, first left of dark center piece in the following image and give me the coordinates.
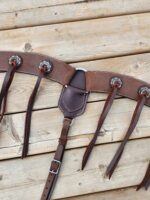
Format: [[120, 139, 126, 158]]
[[22, 61, 52, 159]]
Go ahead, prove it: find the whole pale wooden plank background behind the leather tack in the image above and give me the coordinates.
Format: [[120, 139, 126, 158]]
[[0, 0, 150, 200]]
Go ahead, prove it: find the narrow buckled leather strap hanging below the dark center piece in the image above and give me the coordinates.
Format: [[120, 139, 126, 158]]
[[41, 118, 72, 200]]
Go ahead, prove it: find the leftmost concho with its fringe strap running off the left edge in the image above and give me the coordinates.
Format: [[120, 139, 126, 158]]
[[0, 55, 22, 122]]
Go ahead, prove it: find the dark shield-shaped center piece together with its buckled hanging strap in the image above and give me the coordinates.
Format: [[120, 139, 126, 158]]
[[41, 70, 88, 200]]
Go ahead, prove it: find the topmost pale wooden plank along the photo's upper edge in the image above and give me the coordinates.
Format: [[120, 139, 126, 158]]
[[0, 0, 150, 30]]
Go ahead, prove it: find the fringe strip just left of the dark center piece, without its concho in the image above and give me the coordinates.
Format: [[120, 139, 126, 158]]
[[22, 72, 44, 159]]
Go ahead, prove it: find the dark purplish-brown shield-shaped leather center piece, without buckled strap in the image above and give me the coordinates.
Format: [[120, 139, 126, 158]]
[[58, 70, 88, 118]]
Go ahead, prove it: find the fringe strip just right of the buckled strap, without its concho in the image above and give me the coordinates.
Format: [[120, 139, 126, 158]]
[[82, 87, 118, 170]]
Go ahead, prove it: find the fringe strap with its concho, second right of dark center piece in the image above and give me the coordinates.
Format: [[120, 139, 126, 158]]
[[106, 87, 150, 178]]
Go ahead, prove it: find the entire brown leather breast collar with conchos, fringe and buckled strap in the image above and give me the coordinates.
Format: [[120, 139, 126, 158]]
[[0, 52, 150, 200]]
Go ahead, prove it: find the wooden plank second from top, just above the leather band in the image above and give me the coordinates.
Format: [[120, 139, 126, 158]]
[[0, 13, 150, 62]]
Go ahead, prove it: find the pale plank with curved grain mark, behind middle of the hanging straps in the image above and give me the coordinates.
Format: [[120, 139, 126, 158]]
[[0, 99, 150, 160]]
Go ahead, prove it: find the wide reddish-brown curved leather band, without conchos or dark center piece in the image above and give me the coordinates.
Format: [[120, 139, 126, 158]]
[[0, 51, 150, 106]]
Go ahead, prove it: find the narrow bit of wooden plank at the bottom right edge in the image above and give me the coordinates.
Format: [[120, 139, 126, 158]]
[[63, 188, 150, 200]]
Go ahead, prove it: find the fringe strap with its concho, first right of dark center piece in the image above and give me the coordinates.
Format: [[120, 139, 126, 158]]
[[82, 77, 122, 170]]
